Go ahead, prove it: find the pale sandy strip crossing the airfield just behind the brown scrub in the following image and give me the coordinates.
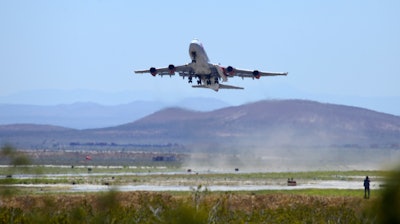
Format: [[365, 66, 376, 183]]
[[3, 172, 382, 192]]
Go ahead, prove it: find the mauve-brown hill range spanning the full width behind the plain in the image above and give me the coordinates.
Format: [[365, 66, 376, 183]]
[[0, 100, 400, 150]]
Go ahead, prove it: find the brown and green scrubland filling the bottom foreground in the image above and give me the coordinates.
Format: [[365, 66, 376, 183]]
[[0, 189, 378, 223]]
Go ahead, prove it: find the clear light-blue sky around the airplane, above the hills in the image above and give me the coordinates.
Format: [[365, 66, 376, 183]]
[[0, 0, 400, 115]]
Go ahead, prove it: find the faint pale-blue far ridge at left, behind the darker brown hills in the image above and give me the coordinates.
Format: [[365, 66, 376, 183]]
[[0, 98, 228, 129]]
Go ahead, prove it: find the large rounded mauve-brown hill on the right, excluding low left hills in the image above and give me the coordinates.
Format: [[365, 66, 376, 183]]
[[103, 100, 400, 145]]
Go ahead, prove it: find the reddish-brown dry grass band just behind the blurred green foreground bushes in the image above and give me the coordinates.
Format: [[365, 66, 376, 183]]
[[1, 192, 371, 212]]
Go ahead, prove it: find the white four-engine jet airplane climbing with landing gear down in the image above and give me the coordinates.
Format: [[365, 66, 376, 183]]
[[135, 39, 288, 91]]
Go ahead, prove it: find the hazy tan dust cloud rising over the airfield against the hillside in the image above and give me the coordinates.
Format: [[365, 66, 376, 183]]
[[184, 121, 400, 172]]
